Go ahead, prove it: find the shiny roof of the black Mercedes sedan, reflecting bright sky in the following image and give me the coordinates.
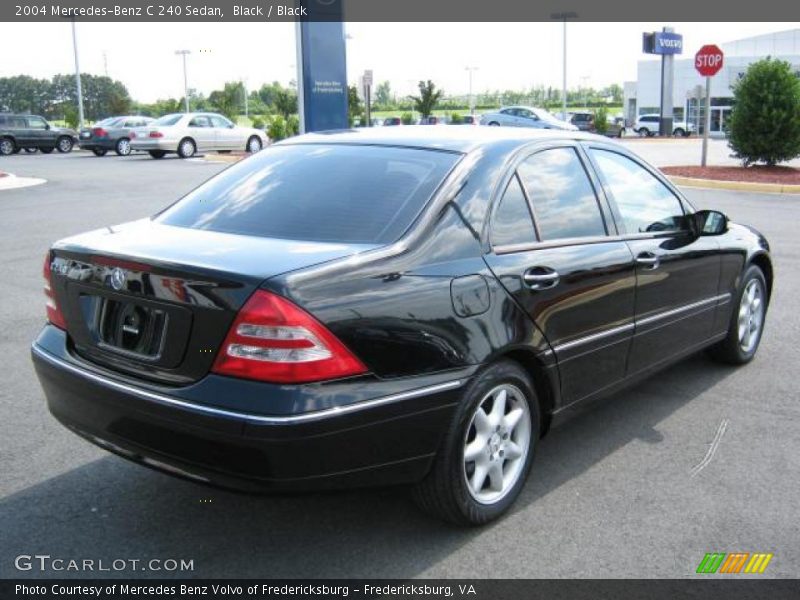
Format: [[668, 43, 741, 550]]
[[278, 125, 606, 153]]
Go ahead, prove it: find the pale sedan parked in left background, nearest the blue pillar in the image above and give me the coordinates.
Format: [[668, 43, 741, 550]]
[[131, 112, 267, 158]]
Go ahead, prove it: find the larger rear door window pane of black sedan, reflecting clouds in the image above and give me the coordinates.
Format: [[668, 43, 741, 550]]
[[518, 148, 606, 241]]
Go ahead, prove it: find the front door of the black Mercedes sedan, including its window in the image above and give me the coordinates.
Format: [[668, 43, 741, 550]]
[[588, 145, 724, 375]]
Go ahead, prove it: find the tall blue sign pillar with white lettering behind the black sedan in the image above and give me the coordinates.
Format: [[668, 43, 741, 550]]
[[297, 0, 349, 132]]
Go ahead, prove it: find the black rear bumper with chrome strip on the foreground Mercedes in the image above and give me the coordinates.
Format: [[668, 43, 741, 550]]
[[32, 326, 468, 491]]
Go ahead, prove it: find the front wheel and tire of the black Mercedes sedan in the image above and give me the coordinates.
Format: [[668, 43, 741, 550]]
[[709, 265, 769, 365]]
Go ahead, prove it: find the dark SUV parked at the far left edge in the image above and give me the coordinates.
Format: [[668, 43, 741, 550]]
[[0, 114, 78, 156]]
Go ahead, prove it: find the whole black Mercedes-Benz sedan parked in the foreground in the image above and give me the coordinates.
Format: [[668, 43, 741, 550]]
[[32, 127, 773, 524]]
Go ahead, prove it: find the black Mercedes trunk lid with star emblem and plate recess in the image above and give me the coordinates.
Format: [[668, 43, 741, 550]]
[[50, 219, 374, 384]]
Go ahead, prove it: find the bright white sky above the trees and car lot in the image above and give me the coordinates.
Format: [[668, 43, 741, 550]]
[[0, 22, 800, 102]]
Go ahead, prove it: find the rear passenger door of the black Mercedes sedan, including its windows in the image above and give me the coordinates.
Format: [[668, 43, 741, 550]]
[[486, 144, 635, 405]]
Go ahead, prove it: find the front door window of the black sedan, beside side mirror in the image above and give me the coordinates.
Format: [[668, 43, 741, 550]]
[[590, 148, 684, 233]]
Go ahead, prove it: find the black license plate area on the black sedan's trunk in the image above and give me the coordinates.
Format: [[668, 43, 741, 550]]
[[95, 298, 169, 361]]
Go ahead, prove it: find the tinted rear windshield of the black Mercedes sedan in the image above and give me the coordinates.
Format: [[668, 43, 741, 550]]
[[156, 144, 460, 244]]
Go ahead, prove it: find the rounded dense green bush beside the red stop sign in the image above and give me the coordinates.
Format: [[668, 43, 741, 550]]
[[728, 57, 800, 166]]
